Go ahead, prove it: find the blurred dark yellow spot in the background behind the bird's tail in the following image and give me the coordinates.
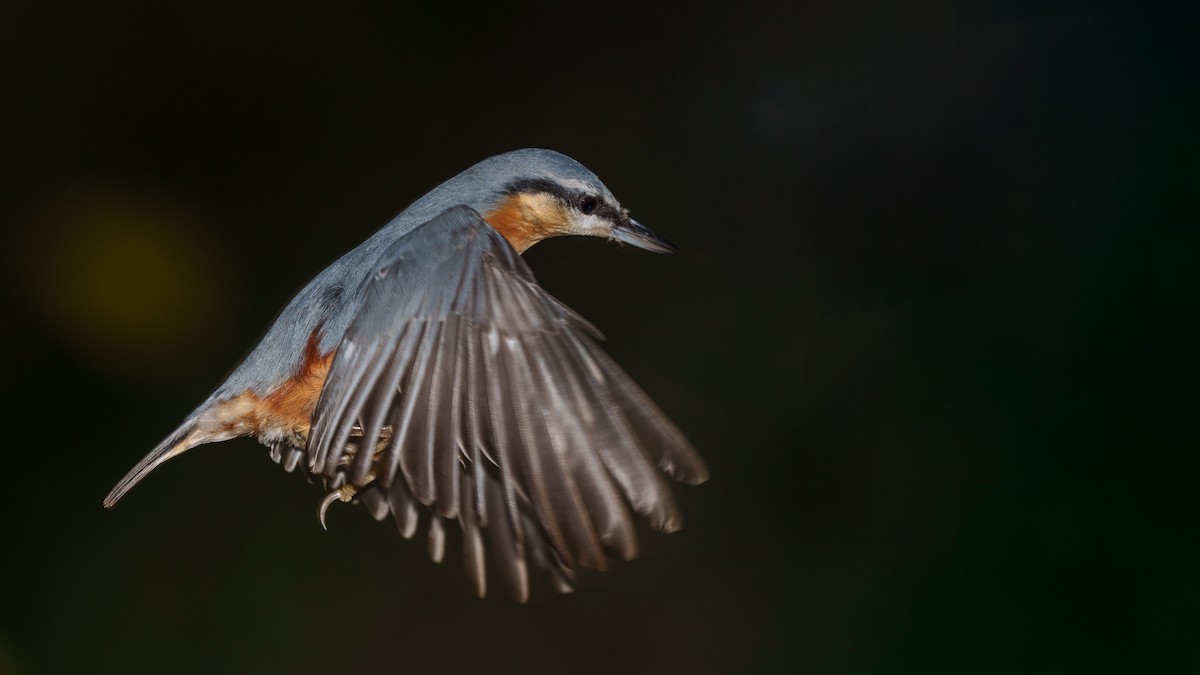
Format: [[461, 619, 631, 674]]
[[22, 189, 224, 369]]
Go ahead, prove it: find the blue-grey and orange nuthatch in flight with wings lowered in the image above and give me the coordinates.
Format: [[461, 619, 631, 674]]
[[103, 149, 708, 603]]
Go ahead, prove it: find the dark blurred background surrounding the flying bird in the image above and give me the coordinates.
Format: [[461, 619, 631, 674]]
[[0, 0, 1200, 674]]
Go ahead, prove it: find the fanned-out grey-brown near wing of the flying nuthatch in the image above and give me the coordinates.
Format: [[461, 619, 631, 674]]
[[308, 207, 707, 601]]
